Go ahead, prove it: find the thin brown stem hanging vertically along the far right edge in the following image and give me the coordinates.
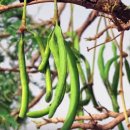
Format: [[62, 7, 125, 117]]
[[119, 32, 130, 130]]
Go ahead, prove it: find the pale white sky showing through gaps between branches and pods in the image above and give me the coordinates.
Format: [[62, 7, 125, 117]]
[[18, 0, 130, 130]]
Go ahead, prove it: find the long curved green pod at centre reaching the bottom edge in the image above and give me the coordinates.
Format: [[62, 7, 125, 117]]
[[61, 46, 80, 130]]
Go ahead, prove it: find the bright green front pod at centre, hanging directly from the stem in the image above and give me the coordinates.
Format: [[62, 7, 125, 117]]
[[49, 24, 67, 117]]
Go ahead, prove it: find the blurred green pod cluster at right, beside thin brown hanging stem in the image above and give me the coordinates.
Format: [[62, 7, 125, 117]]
[[98, 42, 124, 130]]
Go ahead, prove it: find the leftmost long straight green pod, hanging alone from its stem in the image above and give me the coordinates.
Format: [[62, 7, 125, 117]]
[[18, 34, 29, 118]]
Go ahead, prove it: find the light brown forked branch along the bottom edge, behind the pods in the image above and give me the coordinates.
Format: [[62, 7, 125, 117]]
[[35, 109, 130, 130]]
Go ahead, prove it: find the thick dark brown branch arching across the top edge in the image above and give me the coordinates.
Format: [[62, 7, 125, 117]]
[[0, 0, 130, 26]]
